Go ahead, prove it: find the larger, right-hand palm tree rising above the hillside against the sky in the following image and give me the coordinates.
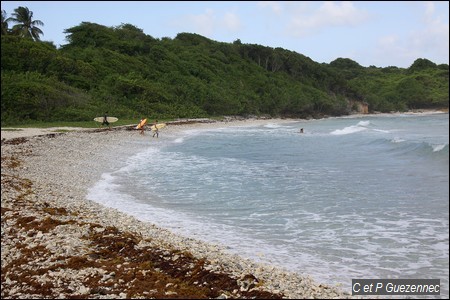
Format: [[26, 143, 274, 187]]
[[8, 6, 44, 41]]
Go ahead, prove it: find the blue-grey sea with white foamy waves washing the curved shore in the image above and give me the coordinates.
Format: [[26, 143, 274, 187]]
[[88, 113, 449, 298]]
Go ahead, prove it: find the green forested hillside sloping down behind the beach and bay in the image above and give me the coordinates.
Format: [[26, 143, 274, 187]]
[[1, 22, 449, 126]]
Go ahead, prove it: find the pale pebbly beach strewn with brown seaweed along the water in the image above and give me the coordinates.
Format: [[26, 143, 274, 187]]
[[1, 120, 351, 299]]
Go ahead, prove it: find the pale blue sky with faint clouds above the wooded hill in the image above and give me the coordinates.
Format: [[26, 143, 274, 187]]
[[1, 1, 449, 68]]
